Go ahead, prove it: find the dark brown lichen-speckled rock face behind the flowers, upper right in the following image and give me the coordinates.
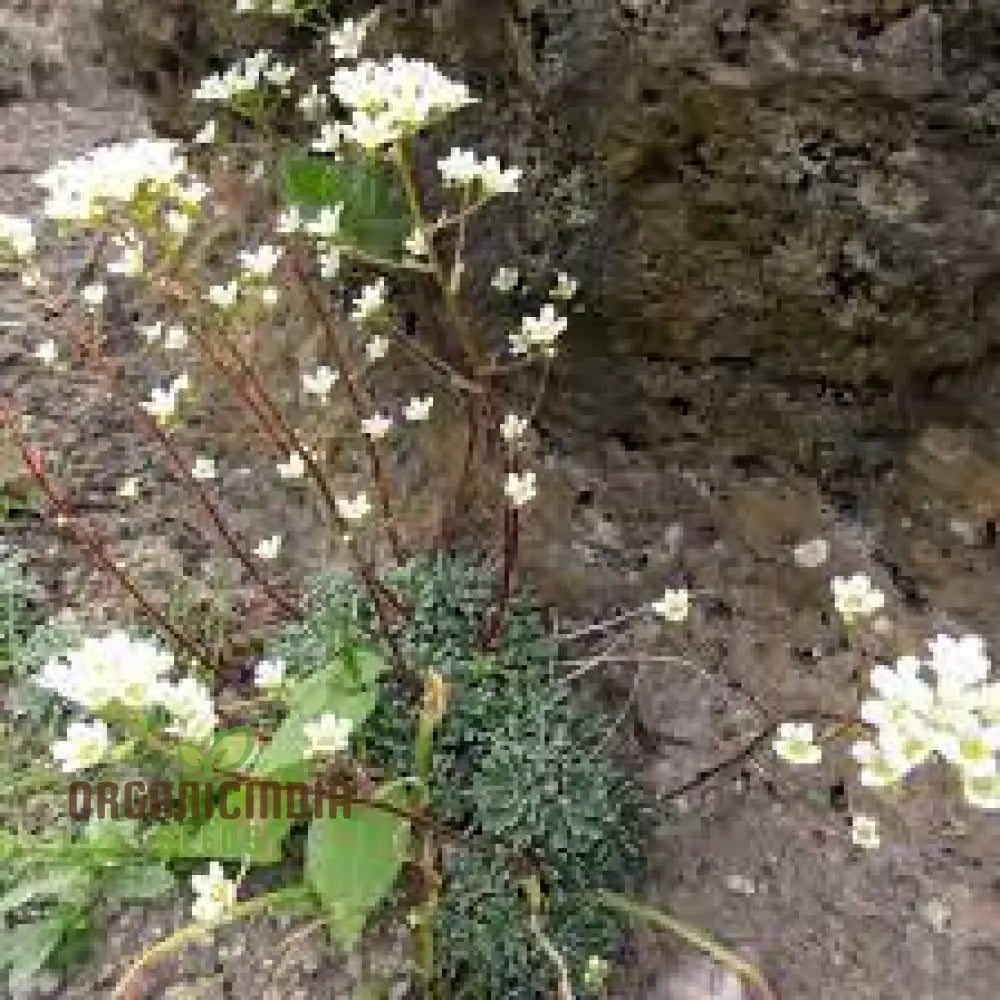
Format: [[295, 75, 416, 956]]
[[94, 0, 1000, 394]]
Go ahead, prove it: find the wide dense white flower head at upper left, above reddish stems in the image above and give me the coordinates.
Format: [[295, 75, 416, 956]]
[[35, 139, 189, 223]]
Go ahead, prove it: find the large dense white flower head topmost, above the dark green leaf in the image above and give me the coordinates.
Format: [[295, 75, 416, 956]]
[[330, 55, 475, 149]]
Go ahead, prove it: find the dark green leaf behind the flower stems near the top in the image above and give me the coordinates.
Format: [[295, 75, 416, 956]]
[[283, 154, 413, 257]]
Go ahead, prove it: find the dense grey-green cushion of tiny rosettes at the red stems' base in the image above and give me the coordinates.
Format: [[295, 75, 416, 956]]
[[275, 554, 648, 1000]]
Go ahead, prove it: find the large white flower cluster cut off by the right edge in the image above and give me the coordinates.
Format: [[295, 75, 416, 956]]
[[852, 635, 1000, 809]]
